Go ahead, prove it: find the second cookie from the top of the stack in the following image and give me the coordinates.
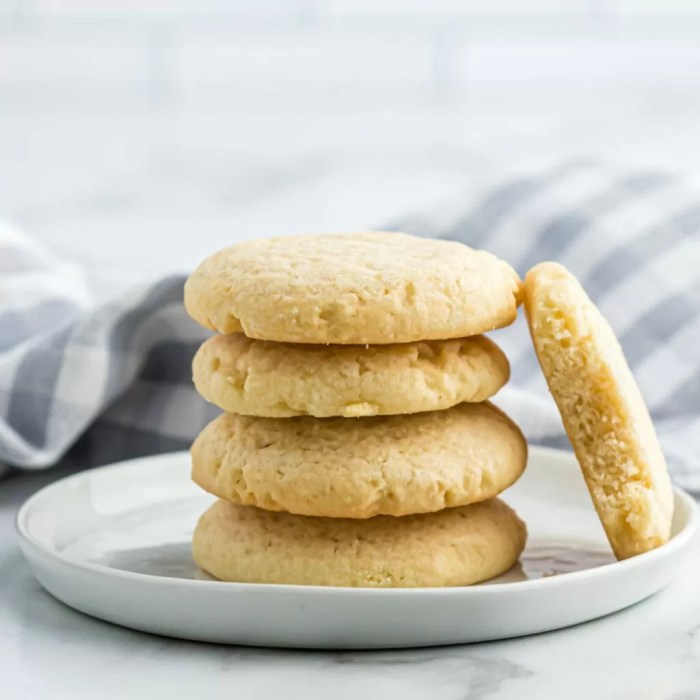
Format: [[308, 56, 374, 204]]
[[192, 333, 510, 418]]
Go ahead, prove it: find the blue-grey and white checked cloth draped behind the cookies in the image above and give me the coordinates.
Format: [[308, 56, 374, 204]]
[[0, 162, 700, 492]]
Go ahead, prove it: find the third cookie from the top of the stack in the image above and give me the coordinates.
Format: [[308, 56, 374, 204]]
[[192, 402, 527, 518]]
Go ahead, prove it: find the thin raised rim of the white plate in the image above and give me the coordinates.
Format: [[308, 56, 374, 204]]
[[15, 445, 700, 597]]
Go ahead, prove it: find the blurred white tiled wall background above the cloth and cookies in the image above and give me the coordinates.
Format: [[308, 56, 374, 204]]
[[0, 0, 700, 296]]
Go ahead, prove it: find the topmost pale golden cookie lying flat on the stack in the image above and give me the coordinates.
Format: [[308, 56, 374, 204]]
[[185, 232, 520, 345]]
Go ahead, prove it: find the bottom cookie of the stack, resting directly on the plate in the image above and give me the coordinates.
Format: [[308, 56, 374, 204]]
[[193, 498, 527, 588]]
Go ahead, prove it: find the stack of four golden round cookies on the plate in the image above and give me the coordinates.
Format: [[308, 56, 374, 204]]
[[185, 233, 527, 587]]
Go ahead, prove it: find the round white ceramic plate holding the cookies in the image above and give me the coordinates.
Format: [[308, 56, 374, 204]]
[[17, 448, 698, 648]]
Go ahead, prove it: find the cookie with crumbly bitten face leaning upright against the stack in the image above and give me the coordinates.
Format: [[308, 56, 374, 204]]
[[525, 263, 673, 559]]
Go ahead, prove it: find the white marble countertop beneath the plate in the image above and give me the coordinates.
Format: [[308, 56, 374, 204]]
[[0, 462, 700, 700]]
